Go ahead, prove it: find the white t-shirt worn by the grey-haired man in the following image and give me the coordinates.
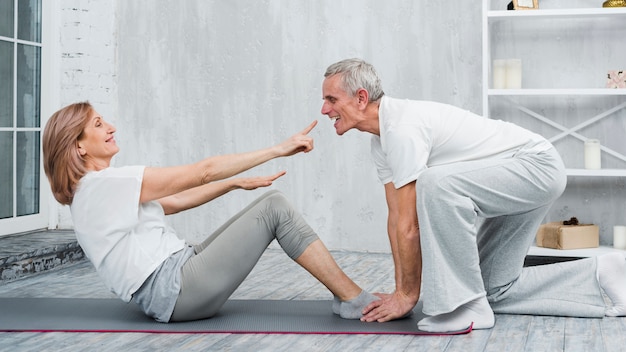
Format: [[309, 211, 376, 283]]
[[371, 96, 552, 188]]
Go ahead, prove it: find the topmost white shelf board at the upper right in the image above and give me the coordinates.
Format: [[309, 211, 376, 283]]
[[487, 8, 626, 18]]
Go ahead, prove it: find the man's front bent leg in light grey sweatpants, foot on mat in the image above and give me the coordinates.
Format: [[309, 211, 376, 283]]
[[417, 147, 565, 331]]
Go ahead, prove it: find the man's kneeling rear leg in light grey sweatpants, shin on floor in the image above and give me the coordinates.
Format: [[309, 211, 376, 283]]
[[478, 206, 604, 317]]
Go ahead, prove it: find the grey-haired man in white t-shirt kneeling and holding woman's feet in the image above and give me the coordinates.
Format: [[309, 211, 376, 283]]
[[321, 59, 626, 332]]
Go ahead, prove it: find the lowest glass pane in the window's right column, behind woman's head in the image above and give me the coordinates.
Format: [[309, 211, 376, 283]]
[[16, 131, 39, 216]]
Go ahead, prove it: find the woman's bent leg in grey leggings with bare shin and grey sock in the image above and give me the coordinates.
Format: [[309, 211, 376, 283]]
[[171, 191, 370, 321]]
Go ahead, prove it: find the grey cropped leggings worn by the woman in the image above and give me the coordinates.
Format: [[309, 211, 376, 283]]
[[171, 191, 318, 321]]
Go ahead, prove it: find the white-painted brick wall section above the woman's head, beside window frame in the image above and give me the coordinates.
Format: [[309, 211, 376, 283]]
[[51, 0, 118, 228]]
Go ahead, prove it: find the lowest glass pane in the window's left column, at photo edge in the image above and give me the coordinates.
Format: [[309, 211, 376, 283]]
[[0, 131, 13, 219]]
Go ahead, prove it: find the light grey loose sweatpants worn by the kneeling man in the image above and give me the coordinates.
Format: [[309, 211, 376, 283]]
[[416, 149, 605, 317]]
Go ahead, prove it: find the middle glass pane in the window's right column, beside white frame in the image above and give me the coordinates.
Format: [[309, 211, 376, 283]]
[[16, 44, 41, 127]]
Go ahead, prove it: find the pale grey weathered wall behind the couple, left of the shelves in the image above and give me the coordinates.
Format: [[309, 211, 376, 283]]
[[51, 0, 623, 251]]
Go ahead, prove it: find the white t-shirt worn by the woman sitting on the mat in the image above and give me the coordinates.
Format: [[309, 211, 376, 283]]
[[70, 166, 185, 302]]
